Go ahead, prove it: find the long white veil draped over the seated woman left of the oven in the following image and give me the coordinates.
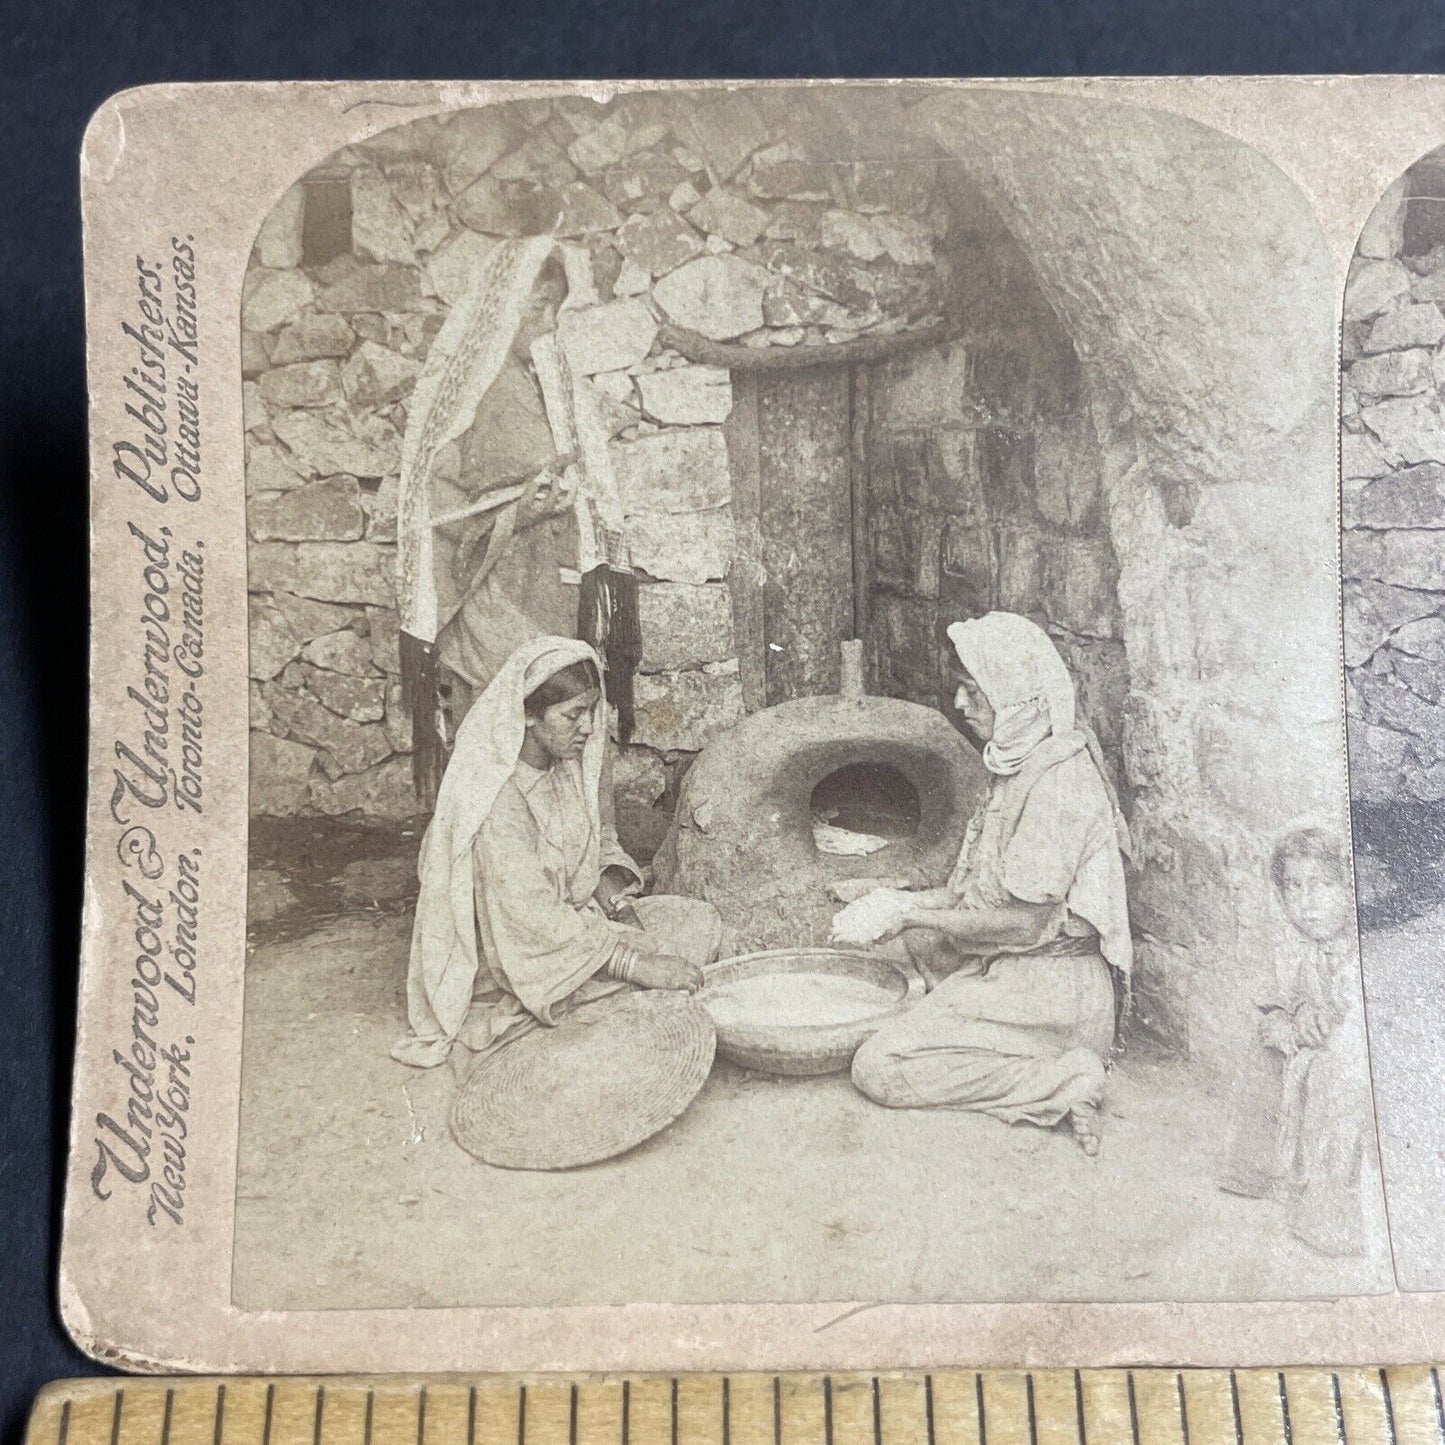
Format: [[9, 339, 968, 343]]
[[392, 637, 607, 1068]]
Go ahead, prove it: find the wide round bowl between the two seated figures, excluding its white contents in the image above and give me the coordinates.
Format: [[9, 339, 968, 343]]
[[698, 948, 909, 1074]]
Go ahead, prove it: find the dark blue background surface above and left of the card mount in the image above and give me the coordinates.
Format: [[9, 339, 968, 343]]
[[0, 0, 1445, 1445]]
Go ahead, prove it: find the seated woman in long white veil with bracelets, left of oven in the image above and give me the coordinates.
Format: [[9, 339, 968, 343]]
[[392, 637, 721, 1068]]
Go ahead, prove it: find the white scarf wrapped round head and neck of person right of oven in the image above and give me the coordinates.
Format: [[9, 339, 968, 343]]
[[948, 613, 1074, 775]]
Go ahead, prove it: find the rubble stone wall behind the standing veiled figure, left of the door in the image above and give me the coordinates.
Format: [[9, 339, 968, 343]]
[[241, 92, 949, 816]]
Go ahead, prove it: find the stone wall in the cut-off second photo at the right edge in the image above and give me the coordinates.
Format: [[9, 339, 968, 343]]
[[1341, 153, 1445, 913]]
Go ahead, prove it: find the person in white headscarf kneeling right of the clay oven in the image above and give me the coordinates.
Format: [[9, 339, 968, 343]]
[[853, 613, 1133, 1155]]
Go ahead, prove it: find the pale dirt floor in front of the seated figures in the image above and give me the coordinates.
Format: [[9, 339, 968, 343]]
[[234, 825, 1389, 1309]]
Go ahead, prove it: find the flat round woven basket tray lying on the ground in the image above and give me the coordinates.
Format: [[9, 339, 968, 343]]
[[451, 990, 717, 1169]]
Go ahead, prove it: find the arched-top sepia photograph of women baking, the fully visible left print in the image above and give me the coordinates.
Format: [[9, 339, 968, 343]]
[[231, 84, 1392, 1311]]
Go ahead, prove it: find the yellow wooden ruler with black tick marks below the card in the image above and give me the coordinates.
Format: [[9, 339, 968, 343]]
[[26, 1366, 1445, 1445]]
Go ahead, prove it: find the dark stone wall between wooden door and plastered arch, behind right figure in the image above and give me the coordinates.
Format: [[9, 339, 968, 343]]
[[867, 169, 1129, 803]]
